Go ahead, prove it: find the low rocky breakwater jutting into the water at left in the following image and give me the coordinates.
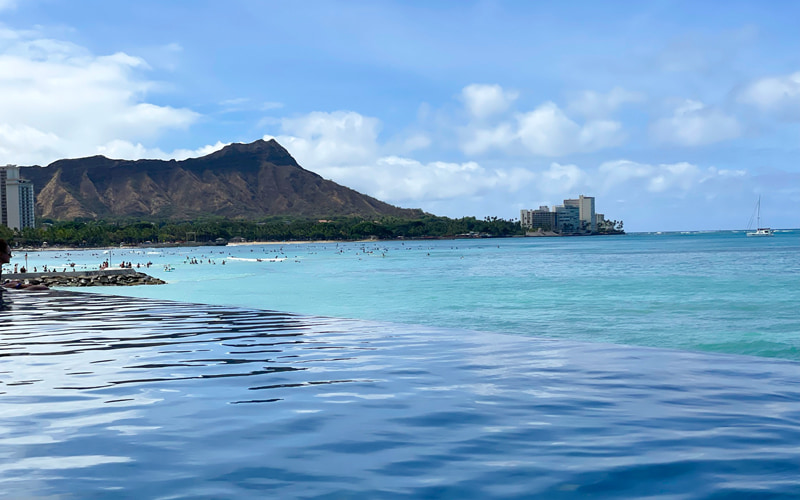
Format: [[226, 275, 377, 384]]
[[3, 269, 166, 287]]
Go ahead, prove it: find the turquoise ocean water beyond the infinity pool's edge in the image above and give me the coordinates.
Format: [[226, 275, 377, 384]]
[[29, 231, 800, 360]]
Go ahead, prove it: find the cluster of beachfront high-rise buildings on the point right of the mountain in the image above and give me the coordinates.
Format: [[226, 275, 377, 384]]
[[519, 195, 597, 234]]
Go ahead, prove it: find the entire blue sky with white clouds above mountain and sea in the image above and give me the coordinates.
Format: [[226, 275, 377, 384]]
[[0, 0, 800, 231]]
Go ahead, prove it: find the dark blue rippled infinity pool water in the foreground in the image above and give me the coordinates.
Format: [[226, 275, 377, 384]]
[[0, 292, 800, 498]]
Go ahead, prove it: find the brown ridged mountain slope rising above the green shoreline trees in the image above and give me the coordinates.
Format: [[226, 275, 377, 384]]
[[20, 140, 422, 220]]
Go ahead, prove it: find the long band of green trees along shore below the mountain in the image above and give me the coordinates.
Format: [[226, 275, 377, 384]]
[[0, 215, 524, 247]]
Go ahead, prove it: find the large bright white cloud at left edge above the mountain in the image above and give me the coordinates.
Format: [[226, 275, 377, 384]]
[[0, 30, 199, 164]]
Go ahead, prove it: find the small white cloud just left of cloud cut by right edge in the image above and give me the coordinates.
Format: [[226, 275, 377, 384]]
[[650, 100, 742, 146]]
